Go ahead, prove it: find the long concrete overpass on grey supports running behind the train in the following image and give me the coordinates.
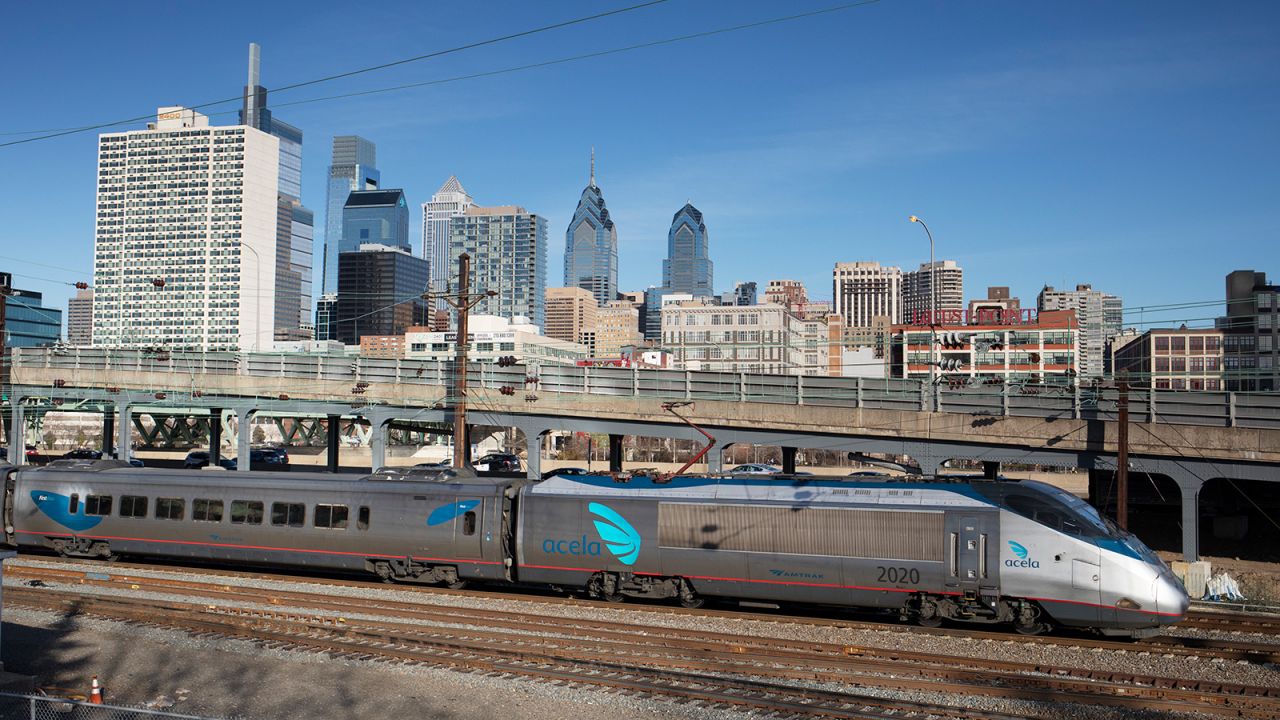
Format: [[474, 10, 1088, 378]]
[[12, 348, 1280, 557]]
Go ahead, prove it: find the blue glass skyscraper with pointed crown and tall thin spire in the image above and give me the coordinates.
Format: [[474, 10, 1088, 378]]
[[564, 149, 618, 305]]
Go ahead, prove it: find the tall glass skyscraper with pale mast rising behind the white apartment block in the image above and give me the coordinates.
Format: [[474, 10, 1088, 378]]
[[239, 42, 315, 340]]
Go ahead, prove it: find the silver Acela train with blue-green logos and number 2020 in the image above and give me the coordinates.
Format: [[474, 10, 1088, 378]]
[[0, 460, 1189, 635]]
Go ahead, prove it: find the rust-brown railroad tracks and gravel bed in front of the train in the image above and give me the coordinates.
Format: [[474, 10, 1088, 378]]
[[5, 556, 1280, 717]]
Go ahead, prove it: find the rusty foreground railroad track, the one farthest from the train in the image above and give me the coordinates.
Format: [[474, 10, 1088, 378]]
[[8, 566, 1280, 717]]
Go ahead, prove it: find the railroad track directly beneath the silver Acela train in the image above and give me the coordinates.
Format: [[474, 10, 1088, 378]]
[[9, 556, 1280, 665]]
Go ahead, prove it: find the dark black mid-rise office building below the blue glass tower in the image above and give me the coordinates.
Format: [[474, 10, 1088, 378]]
[[330, 243, 429, 345]]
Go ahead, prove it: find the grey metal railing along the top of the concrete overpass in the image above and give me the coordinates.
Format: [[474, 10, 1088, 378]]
[[13, 347, 1280, 429]]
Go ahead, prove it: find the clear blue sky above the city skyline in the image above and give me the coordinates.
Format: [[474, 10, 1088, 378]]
[[0, 0, 1280, 327]]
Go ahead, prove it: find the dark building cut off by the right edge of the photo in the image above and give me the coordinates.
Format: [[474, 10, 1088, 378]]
[[1217, 270, 1280, 392]]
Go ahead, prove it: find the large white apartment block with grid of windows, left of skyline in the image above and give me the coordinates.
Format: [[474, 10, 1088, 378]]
[[93, 106, 280, 351]]
